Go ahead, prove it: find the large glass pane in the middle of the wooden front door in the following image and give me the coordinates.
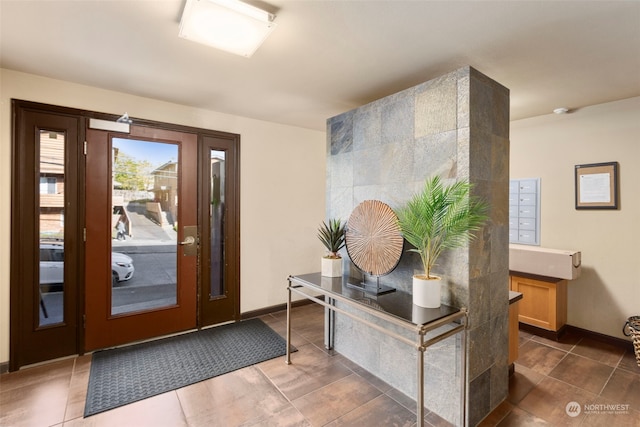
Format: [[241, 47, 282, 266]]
[[111, 138, 179, 315]]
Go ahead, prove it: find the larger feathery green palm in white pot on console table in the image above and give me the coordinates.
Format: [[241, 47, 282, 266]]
[[397, 175, 488, 308]]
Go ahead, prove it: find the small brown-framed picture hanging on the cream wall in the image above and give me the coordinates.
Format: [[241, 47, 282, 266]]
[[575, 162, 618, 209]]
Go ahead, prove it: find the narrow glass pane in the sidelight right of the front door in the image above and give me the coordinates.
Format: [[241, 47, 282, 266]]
[[209, 150, 225, 299]]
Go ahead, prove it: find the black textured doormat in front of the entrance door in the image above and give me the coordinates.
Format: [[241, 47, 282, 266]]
[[84, 319, 287, 417]]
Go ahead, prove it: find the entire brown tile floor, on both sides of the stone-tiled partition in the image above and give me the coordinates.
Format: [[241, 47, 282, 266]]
[[0, 304, 640, 427]]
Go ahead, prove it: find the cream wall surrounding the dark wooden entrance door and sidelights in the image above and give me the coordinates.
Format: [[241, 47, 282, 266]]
[[0, 69, 326, 363]]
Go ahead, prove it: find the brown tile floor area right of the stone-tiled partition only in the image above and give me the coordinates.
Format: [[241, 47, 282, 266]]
[[481, 331, 640, 427]]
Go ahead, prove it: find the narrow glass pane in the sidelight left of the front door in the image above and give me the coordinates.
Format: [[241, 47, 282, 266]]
[[35, 130, 65, 326]]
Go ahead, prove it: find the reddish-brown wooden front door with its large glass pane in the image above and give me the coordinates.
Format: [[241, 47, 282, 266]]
[[85, 126, 198, 350]]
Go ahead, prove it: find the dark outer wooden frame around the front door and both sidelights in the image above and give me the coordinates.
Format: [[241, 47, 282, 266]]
[[9, 99, 240, 371]]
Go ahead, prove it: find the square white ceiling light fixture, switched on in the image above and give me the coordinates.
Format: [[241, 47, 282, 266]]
[[178, 0, 276, 58]]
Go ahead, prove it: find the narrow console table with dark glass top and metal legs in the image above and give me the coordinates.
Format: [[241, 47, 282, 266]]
[[285, 273, 467, 427]]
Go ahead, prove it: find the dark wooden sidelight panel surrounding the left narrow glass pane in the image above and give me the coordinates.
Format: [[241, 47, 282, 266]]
[[9, 100, 84, 371]]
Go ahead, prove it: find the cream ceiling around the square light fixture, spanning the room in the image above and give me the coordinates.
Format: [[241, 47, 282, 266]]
[[0, 0, 640, 130]]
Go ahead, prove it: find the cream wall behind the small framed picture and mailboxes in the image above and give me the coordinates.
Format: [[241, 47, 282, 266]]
[[510, 97, 640, 338]]
